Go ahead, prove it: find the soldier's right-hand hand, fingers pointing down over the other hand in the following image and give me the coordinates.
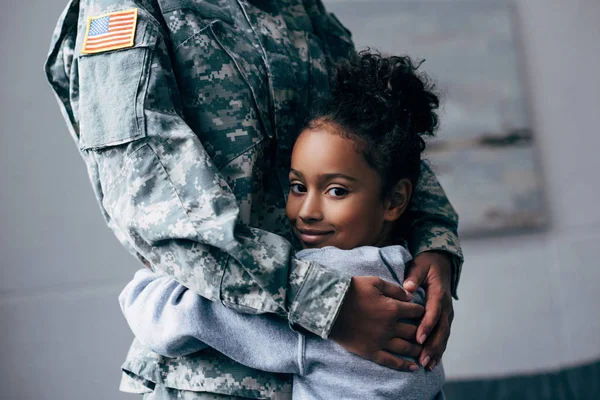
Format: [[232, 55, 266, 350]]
[[404, 251, 454, 370]]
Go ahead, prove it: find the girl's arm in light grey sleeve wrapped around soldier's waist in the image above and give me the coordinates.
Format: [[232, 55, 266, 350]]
[[119, 269, 304, 374]]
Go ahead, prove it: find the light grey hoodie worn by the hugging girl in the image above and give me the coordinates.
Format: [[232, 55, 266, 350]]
[[119, 246, 444, 400]]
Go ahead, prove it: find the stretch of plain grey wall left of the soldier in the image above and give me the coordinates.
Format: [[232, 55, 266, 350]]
[[0, 0, 137, 400]]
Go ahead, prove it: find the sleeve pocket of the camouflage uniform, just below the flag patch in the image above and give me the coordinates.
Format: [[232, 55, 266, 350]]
[[78, 21, 157, 150]]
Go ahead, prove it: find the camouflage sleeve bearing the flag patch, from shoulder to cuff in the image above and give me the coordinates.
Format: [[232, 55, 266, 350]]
[[46, 0, 350, 337]]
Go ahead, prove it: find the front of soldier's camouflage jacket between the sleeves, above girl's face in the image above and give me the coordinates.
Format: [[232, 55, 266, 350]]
[[163, 0, 327, 166]]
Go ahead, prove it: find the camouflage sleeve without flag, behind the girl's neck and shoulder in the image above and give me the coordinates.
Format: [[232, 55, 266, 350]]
[[406, 162, 463, 298]]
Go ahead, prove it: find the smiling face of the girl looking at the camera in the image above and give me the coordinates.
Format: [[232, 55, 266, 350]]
[[286, 124, 396, 249]]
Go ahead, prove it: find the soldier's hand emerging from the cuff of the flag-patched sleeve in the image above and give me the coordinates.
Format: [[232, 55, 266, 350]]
[[330, 276, 425, 371]]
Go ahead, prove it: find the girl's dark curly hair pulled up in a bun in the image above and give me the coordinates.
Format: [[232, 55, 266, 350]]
[[305, 50, 439, 196]]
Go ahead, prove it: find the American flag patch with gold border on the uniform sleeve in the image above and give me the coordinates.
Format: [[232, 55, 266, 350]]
[[81, 8, 138, 54]]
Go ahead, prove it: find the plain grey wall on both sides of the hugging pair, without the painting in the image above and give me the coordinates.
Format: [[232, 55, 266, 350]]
[[0, 0, 600, 399]]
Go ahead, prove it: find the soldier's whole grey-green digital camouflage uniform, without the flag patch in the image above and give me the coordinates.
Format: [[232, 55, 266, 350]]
[[46, 0, 462, 399]]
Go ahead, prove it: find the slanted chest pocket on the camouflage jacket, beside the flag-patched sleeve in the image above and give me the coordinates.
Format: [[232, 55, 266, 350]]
[[170, 18, 271, 168]]
